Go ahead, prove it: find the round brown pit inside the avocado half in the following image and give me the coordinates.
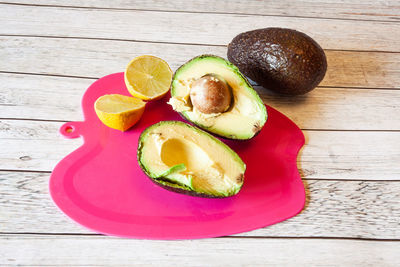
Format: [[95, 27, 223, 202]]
[[190, 74, 232, 114]]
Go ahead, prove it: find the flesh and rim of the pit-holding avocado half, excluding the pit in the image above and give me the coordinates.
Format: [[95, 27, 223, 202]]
[[169, 55, 267, 140]]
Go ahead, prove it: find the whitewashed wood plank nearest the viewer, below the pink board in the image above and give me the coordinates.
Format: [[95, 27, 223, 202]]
[[0, 235, 400, 266]]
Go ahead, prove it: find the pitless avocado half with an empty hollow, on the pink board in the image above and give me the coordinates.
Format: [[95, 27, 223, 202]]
[[138, 121, 246, 197]]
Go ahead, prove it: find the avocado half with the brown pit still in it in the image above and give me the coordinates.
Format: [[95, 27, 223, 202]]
[[168, 55, 267, 140]]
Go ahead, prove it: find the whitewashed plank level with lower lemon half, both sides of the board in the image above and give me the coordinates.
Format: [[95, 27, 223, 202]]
[[0, 71, 400, 130]]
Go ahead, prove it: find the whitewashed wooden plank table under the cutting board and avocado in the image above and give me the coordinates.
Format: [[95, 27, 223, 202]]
[[0, 0, 400, 266]]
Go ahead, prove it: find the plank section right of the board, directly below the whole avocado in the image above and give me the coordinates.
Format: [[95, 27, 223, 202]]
[[256, 87, 400, 130]]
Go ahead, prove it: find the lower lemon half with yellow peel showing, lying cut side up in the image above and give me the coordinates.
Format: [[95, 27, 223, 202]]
[[94, 94, 146, 131]]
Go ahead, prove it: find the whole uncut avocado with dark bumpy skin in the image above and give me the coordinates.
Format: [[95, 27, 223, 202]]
[[228, 28, 327, 95]]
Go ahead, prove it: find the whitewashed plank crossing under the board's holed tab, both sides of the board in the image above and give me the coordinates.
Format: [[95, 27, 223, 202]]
[[0, 120, 400, 180]]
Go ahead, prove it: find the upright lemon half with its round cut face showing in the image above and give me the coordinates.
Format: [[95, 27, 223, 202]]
[[124, 55, 172, 100]]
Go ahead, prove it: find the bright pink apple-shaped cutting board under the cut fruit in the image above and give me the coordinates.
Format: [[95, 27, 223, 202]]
[[50, 73, 305, 239]]
